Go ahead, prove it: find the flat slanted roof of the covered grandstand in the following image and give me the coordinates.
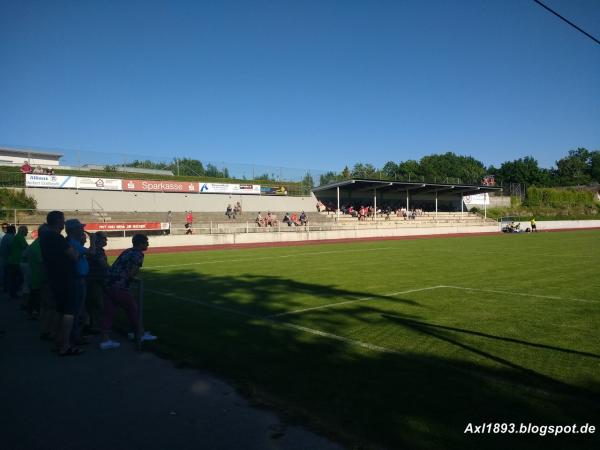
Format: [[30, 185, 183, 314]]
[[313, 179, 502, 195]]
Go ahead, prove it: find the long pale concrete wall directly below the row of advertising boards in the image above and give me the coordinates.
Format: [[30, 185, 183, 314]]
[[25, 188, 317, 212]]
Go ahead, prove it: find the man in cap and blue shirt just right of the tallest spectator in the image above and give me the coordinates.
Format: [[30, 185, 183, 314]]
[[65, 219, 96, 345]]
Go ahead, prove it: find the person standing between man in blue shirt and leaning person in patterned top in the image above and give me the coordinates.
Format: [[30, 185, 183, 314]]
[[85, 231, 110, 333]]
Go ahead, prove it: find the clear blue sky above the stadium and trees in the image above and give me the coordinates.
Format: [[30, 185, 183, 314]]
[[0, 0, 600, 174]]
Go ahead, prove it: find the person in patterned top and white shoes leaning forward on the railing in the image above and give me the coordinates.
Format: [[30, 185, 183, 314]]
[[100, 234, 156, 350]]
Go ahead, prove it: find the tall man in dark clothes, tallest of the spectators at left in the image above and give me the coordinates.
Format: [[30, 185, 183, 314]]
[[40, 211, 82, 356]]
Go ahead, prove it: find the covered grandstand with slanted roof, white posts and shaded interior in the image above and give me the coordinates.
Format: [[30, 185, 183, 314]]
[[312, 179, 502, 218]]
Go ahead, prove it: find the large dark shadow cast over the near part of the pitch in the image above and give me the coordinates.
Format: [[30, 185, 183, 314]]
[[136, 270, 600, 449]]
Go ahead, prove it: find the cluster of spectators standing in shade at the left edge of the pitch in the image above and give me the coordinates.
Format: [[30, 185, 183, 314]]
[[0, 211, 156, 356]]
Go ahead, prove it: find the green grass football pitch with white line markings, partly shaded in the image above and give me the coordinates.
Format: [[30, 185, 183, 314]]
[[131, 231, 600, 449]]
